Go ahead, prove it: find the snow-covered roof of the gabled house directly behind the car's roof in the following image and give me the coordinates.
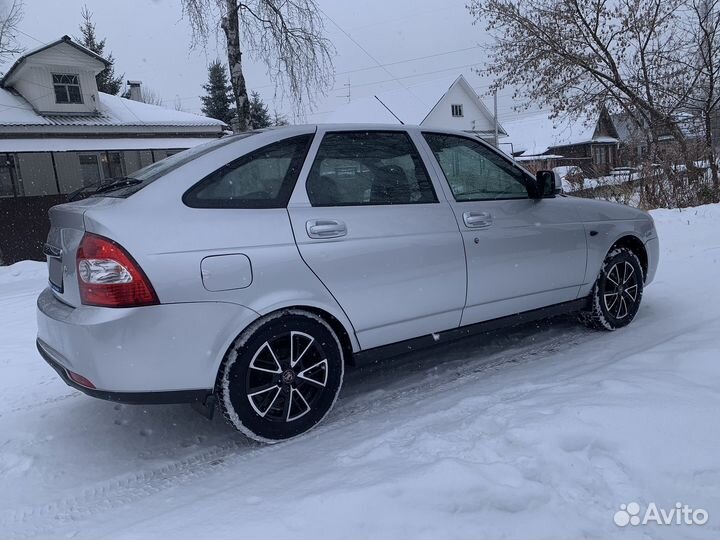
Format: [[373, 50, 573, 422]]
[[328, 75, 504, 134]]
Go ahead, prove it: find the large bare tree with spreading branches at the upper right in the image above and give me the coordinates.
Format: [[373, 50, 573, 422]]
[[468, 0, 718, 205]]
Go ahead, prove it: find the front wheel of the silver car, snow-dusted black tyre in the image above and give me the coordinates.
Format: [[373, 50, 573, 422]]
[[580, 248, 644, 331]]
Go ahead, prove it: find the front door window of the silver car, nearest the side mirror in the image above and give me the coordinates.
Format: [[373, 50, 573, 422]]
[[423, 133, 528, 202]]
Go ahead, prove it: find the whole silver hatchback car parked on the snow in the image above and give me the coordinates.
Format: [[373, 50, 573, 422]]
[[37, 125, 658, 442]]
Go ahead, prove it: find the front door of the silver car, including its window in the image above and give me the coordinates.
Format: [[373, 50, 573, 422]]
[[423, 133, 587, 325]]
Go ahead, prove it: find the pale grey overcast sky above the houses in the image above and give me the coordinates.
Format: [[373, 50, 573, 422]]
[[0, 0, 524, 122]]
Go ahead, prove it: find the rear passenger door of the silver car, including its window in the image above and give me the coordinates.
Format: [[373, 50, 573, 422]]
[[288, 129, 466, 349]]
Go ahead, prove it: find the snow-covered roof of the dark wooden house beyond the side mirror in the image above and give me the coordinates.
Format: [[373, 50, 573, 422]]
[[503, 111, 618, 156]]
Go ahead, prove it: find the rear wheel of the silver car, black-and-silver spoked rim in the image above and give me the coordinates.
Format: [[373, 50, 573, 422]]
[[215, 309, 345, 443]]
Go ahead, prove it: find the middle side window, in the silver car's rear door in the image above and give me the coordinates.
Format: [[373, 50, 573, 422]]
[[307, 131, 437, 206]]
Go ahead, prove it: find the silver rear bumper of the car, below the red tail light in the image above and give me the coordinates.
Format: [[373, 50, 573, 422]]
[[37, 289, 258, 396]]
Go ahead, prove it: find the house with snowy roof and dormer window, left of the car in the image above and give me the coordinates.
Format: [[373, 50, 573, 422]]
[[0, 36, 227, 262]]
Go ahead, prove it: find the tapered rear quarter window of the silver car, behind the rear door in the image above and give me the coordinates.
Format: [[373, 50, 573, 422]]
[[183, 135, 313, 208]]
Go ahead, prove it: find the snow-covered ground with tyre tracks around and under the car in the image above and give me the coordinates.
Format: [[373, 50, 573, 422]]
[[0, 205, 720, 540]]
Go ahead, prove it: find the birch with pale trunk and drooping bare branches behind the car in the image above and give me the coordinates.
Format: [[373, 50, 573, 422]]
[[182, 0, 333, 131]]
